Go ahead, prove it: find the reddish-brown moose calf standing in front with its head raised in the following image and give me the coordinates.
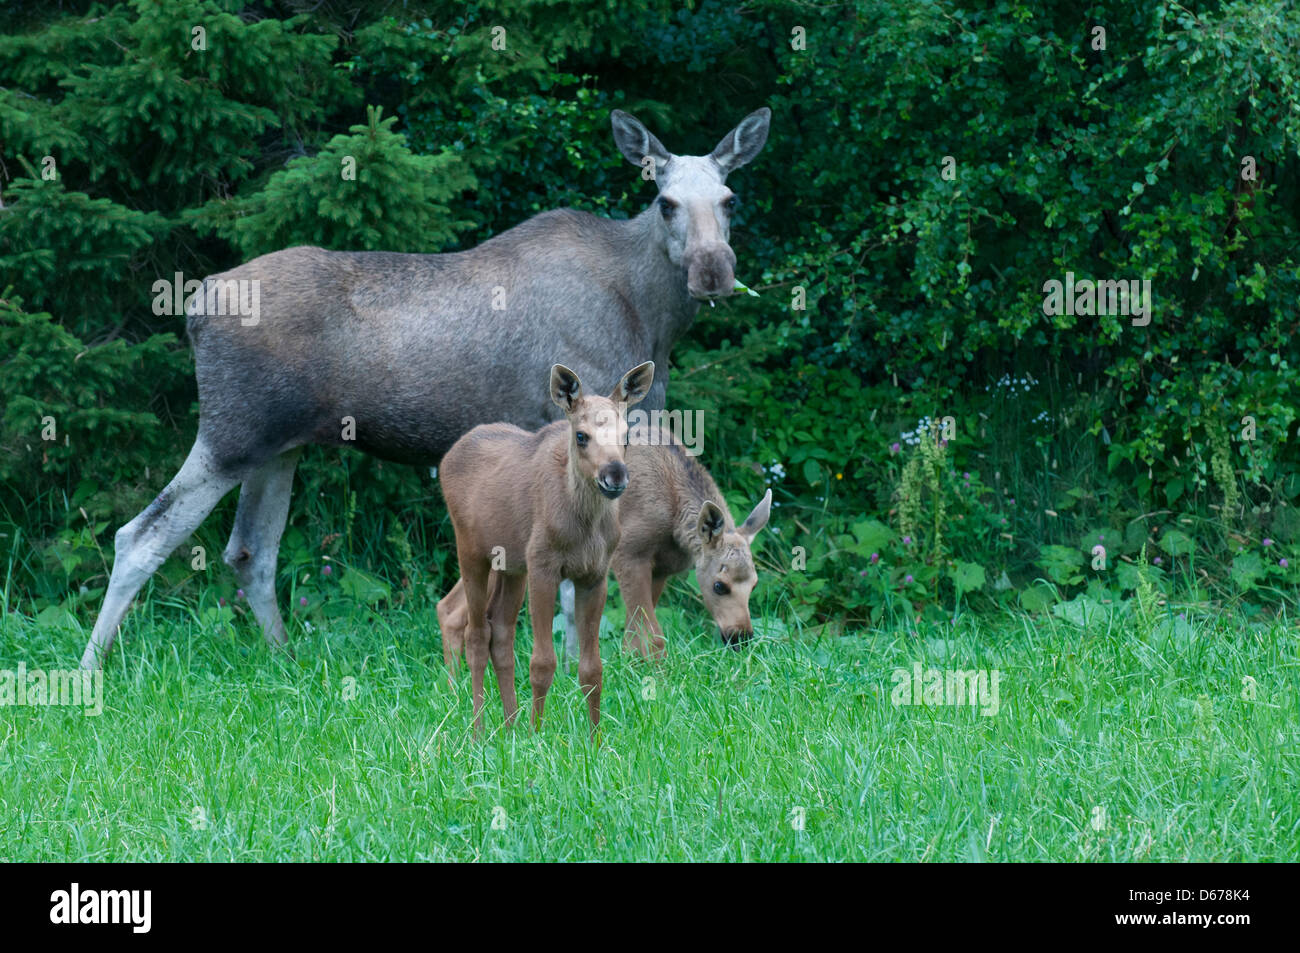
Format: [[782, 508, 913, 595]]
[[441, 361, 654, 732]]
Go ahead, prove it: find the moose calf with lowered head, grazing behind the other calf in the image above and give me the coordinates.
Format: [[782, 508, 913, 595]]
[[438, 425, 772, 660]]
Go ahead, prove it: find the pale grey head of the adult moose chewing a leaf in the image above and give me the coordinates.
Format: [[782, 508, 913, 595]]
[[610, 107, 772, 300]]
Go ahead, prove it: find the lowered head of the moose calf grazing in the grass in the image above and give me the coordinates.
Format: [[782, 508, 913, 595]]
[[696, 490, 772, 646]]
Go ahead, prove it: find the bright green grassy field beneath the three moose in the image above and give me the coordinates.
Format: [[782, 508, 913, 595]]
[[0, 587, 1300, 861]]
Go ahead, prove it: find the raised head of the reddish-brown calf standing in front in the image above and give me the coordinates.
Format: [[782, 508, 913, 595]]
[[551, 360, 654, 499]]
